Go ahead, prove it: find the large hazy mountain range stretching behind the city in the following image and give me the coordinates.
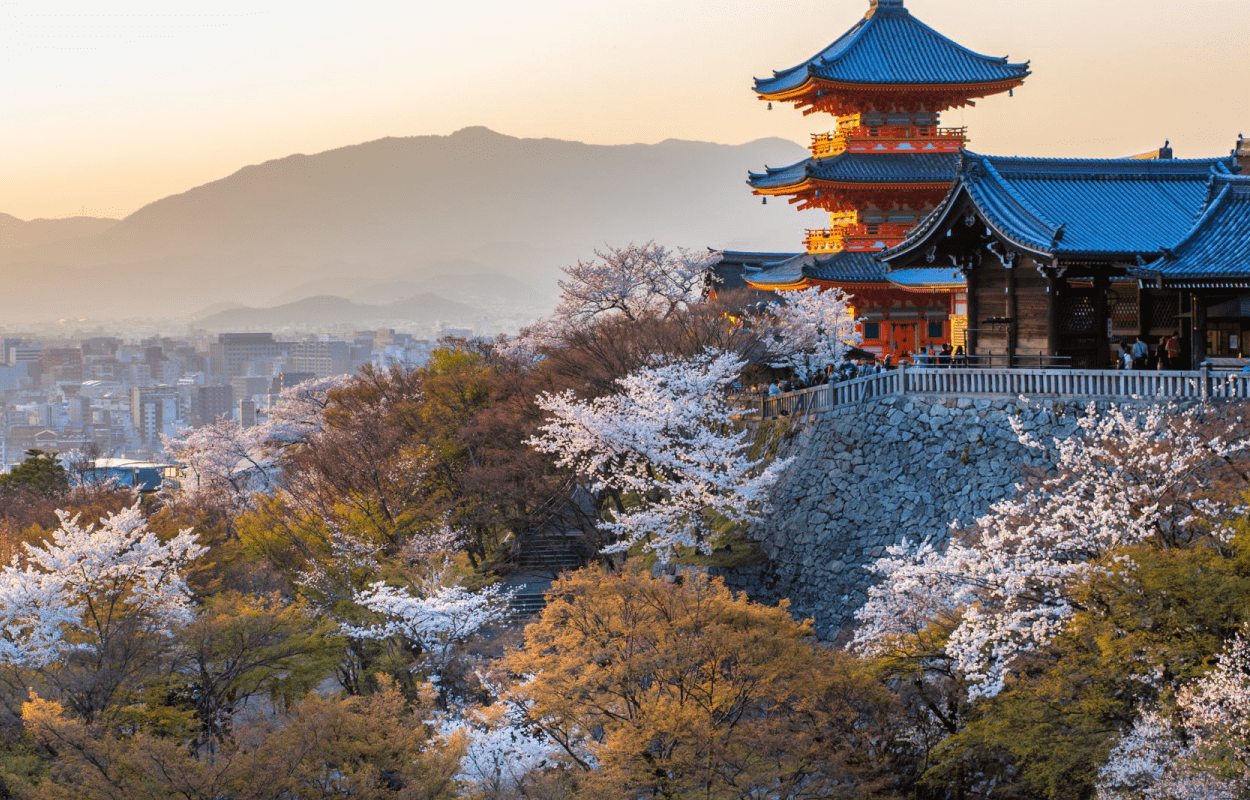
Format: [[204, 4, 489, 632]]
[[0, 128, 821, 318]]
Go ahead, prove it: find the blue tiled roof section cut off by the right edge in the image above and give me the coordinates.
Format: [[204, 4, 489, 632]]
[[1134, 175, 1250, 283]]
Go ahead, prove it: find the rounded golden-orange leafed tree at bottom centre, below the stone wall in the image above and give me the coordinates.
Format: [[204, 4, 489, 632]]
[[505, 570, 894, 799]]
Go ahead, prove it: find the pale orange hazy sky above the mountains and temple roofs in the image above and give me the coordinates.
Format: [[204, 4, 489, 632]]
[[0, 0, 1250, 219]]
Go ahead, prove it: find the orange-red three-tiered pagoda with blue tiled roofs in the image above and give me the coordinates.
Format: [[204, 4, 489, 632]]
[[744, 0, 1029, 355]]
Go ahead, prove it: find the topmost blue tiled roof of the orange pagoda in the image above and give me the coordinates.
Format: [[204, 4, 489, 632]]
[[755, 3, 1029, 95]]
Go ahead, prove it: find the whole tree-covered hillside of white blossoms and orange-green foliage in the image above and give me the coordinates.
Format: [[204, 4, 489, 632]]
[[0, 245, 1250, 800]]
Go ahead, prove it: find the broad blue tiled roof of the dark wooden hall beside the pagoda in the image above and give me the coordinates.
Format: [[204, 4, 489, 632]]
[[883, 151, 1236, 261]]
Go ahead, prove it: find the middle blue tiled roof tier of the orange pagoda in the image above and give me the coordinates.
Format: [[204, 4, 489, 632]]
[[746, 151, 959, 189]]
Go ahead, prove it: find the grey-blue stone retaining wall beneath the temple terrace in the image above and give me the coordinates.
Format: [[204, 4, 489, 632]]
[[726, 398, 1081, 639]]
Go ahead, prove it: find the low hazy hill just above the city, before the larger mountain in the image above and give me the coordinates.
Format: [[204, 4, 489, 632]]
[[196, 294, 475, 331]]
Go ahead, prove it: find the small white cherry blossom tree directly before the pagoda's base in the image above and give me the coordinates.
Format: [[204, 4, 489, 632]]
[[755, 286, 864, 376]]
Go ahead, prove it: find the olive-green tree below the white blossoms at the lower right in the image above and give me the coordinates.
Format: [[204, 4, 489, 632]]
[[925, 524, 1250, 800]]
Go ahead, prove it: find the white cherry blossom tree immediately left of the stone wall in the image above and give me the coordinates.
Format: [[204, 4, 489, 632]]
[[530, 350, 788, 561]]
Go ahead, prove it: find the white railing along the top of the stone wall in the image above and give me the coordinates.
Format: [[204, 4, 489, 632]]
[[746, 368, 1250, 419]]
